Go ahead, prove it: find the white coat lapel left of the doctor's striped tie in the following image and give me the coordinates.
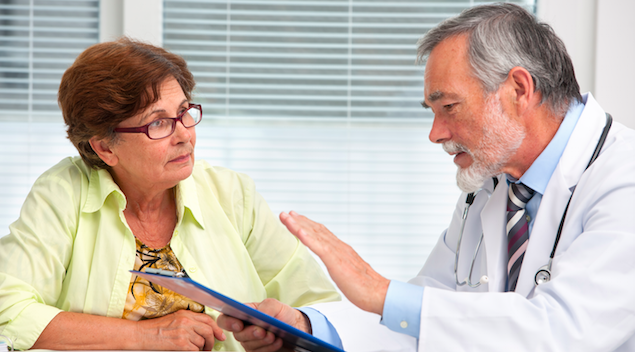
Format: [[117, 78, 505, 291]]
[[481, 176, 507, 292]]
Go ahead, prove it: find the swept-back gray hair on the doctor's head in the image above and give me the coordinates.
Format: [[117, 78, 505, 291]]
[[417, 3, 582, 117]]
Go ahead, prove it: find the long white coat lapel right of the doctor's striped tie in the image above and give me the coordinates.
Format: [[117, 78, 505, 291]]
[[516, 94, 606, 296]]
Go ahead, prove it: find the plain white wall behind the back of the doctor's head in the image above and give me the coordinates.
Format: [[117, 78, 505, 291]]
[[538, 0, 635, 128]]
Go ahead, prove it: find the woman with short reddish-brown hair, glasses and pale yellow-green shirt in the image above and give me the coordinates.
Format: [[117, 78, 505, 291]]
[[0, 38, 339, 350]]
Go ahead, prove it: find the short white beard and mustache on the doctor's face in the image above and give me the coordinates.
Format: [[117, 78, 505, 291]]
[[443, 93, 525, 193]]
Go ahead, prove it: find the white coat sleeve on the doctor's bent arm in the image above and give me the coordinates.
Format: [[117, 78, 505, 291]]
[[418, 144, 635, 352]]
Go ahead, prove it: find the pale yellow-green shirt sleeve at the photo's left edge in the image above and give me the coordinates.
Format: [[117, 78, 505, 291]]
[[0, 158, 79, 349]]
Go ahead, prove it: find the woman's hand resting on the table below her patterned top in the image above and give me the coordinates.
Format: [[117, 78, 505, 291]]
[[137, 310, 225, 351]]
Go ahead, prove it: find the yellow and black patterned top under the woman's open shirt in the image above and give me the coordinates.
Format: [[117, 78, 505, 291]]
[[123, 239, 205, 320]]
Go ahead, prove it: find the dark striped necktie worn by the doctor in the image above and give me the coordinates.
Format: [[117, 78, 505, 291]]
[[507, 183, 534, 291]]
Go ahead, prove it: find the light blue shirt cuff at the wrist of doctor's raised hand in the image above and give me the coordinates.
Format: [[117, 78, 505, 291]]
[[381, 281, 423, 339]]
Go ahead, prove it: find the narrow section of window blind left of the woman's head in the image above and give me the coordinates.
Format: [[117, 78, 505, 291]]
[[0, 0, 99, 231]]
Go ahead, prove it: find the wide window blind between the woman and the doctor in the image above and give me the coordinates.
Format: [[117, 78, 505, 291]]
[[163, 0, 533, 280]]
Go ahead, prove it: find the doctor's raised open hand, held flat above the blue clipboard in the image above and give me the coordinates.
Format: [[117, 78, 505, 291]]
[[280, 211, 390, 315]]
